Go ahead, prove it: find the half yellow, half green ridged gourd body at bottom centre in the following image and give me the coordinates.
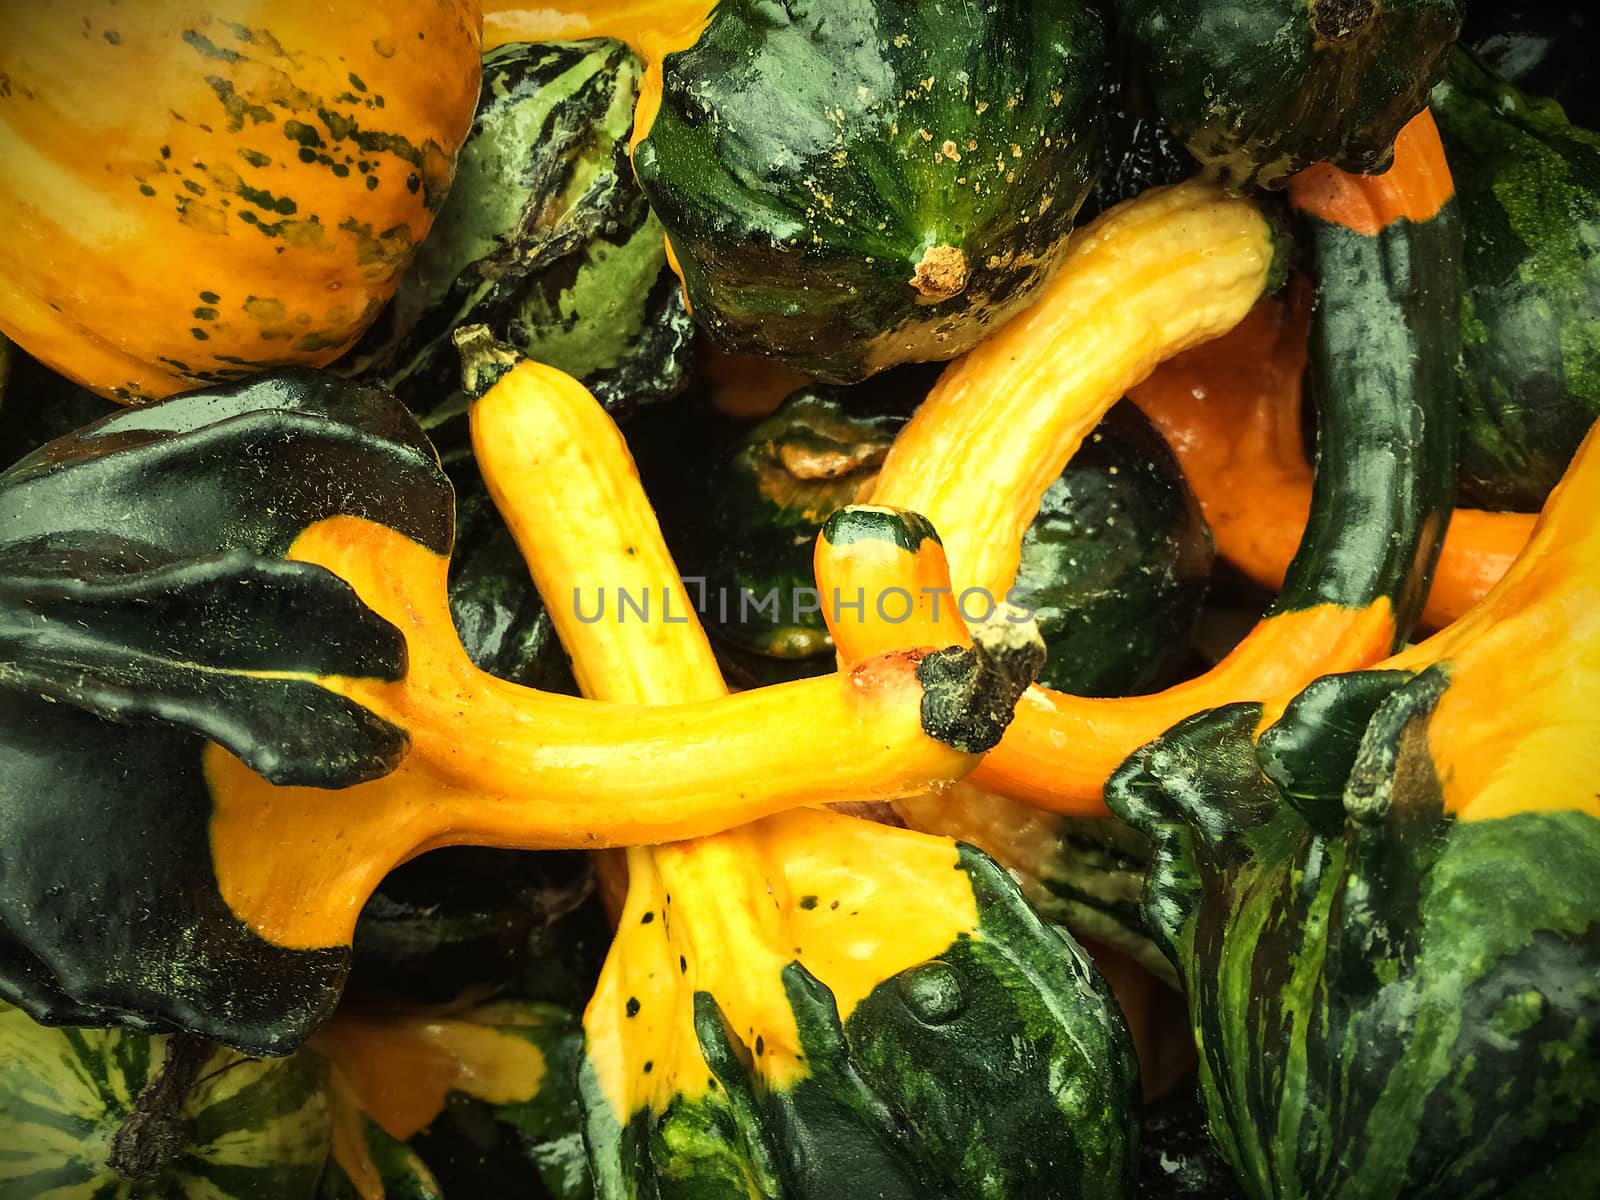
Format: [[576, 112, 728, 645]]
[[584, 811, 1138, 1200]]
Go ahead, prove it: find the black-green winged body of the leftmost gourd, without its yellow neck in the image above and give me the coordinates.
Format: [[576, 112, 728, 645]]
[[0, 370, 453, 1054]]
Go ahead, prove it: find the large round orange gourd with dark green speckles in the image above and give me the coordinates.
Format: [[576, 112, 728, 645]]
[[0, 0, 482, 400]]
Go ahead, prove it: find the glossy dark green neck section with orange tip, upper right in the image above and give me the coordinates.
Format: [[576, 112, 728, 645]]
[[1274, 115, 1462, 633]]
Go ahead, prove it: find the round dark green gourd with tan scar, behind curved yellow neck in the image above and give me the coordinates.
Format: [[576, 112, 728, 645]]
[[685, 376, 1211, 696]]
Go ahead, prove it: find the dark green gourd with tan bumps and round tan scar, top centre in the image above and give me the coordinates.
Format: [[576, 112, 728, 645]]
[[634, 0, 1106, 382]]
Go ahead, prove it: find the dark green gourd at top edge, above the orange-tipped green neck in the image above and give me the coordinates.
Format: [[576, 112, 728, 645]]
[[1117, 0, 1462, 189]]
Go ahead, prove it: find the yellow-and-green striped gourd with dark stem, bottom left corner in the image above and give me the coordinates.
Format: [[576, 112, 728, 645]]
[[0, 1005, 331, 1200]]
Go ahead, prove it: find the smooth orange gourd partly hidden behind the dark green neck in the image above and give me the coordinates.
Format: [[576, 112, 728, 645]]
[[1128, 288, 1533, 629]]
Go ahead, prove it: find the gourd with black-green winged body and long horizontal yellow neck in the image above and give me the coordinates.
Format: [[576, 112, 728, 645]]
[[0, 370, 1022, 1053]]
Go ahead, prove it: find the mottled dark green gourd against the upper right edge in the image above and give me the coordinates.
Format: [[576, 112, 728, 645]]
[[1434, 53, 1600, 512]]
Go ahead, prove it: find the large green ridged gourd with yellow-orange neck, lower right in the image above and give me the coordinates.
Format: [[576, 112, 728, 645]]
[[1107, 419, 1600, 1200]]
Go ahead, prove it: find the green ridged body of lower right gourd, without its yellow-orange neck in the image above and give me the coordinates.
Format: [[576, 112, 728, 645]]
[[1107, 672, 1600, 1200]]
